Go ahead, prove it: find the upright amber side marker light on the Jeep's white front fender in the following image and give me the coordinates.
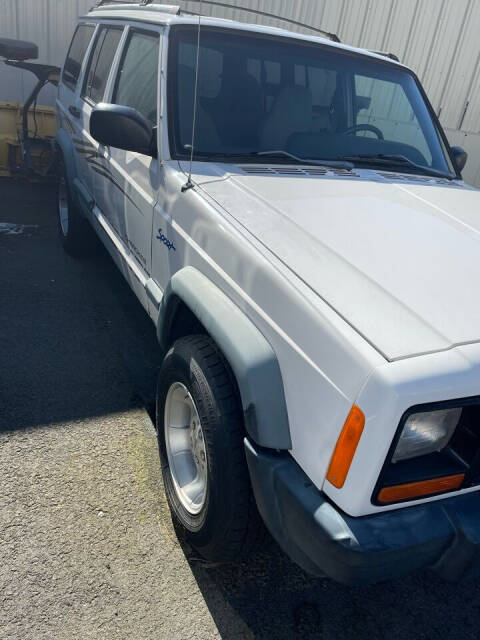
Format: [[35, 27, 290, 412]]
[[327, 404, 365, 489]]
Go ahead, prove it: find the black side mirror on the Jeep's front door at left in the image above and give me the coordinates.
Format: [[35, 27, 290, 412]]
[[90, 103, 157, 158]]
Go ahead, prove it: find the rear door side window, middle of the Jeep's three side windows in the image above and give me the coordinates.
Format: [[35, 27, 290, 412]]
[[82, 27, 123, 102]]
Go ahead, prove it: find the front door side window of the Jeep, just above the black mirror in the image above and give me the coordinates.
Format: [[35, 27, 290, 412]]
[[112, 31, 160, 126]]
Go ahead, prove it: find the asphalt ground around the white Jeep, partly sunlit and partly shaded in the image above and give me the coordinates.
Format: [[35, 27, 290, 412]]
[[0, 176, 480, 640]]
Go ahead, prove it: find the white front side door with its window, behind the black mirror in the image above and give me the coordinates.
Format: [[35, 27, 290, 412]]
[[95, 26, 162, 308]]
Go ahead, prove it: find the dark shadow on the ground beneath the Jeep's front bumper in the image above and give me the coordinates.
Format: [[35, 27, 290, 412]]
[[187, 543, 480, 640]]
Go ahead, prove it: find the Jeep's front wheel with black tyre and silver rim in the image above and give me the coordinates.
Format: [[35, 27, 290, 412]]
[[157, 335, 264, 562]]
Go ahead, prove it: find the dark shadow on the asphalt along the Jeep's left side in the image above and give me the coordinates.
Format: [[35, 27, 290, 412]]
[[0, 180, 160, 431]]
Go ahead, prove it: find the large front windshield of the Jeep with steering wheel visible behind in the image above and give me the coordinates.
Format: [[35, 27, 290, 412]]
[[168, 27, 452, 174]]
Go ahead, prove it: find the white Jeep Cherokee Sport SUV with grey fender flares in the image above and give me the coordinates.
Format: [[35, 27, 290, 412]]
[[57, 3, 480, 584]]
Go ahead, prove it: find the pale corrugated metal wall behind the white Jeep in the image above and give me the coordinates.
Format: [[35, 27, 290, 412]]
[[0, 0, 480, 185]]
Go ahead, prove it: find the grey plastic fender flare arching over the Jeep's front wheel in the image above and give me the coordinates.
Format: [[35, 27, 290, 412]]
[[157, 267, 292, 450]]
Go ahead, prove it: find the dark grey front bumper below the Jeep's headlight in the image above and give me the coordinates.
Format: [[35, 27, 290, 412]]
[[245, 439, 480, 585]]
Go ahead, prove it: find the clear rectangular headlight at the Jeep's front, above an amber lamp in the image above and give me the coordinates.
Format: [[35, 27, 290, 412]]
[[392, 408, 462, 462]]
